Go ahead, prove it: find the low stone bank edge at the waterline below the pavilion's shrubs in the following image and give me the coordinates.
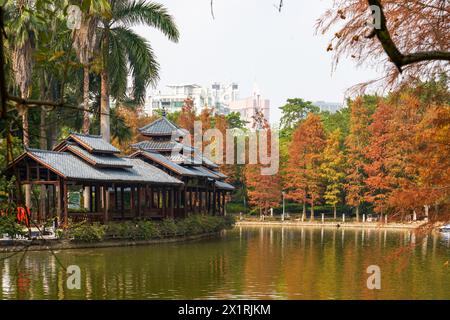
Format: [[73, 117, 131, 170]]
[[0, 231, 221, 253]]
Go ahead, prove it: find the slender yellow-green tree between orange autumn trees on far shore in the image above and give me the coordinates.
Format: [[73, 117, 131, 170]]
[[320, 129, 345, 219]]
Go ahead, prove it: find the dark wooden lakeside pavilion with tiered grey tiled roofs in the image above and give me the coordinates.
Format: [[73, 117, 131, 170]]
[[7, 116, 234, 223]]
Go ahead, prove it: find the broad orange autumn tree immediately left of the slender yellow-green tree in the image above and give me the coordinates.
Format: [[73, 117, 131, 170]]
[[285, 113, 326, 220]]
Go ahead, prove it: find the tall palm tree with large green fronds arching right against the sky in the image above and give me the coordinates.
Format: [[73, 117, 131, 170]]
[[100, 0, 179, 141]]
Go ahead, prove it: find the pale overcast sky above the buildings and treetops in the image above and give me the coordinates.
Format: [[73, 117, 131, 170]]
[[136, 0, 384, 123]]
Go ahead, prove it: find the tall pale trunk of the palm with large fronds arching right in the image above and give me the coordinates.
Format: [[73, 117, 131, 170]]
[[100, 28, 111, 142]]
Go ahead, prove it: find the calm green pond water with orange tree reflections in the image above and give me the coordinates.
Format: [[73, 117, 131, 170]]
[[0, 227, 450, 299]]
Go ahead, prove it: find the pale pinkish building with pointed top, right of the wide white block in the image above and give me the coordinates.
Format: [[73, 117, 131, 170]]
[[229, 84, 270, 129]]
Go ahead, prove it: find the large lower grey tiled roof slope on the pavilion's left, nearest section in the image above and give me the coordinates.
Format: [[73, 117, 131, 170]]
[[27, 149, 183, 184]]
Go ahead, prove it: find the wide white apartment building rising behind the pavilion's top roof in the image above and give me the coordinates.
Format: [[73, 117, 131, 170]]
[[144, 82, 239, 115]]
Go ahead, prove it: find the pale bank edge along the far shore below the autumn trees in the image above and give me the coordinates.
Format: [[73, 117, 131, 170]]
[[235, 220, 426, 229]]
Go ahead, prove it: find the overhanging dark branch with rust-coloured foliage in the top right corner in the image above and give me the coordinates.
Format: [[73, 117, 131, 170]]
[[316, 0, 450, 92]]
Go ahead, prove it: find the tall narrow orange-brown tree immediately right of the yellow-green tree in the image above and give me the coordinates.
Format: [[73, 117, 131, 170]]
[[344, 97, 370, 220]]
